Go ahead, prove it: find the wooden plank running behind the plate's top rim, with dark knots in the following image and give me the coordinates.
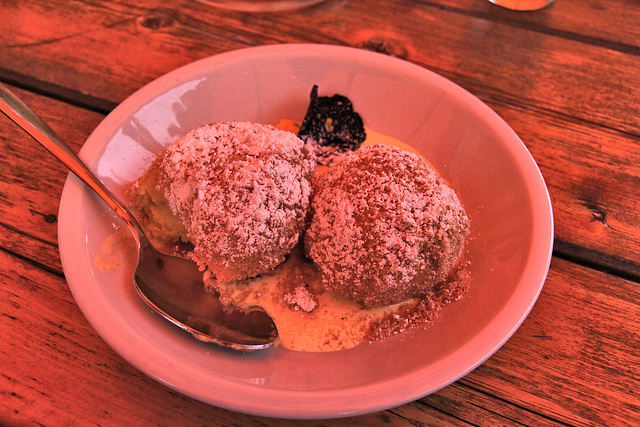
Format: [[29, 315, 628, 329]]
[[0, 0, 640, 135]]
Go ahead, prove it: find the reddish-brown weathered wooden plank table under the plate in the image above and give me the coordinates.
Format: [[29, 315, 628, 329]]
[[0, 0, 640, 426]]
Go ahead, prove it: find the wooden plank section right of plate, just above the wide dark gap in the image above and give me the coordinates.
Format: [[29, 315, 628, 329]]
[[488, 101, 640, 270]]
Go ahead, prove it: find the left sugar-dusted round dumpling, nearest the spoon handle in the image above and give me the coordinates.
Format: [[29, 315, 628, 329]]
[[156, 122, 315, 281]]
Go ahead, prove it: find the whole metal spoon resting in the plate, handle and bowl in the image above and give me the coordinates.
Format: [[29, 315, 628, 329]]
[[0, 84, 276, 351]]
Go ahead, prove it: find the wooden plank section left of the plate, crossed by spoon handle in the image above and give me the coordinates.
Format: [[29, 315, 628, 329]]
[[0, 88, 103, 274]]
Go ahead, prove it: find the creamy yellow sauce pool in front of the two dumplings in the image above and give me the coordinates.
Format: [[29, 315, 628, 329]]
[[205, 247, 417, 352]]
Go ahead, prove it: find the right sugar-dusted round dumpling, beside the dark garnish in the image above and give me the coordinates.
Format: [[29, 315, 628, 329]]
[[305, 145, 468, 306]]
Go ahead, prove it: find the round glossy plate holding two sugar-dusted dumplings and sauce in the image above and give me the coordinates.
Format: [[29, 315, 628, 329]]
[[59, 45, 553, 419]]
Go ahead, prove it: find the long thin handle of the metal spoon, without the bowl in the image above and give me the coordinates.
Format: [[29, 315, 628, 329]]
[[0, 83, 141, 246]]
